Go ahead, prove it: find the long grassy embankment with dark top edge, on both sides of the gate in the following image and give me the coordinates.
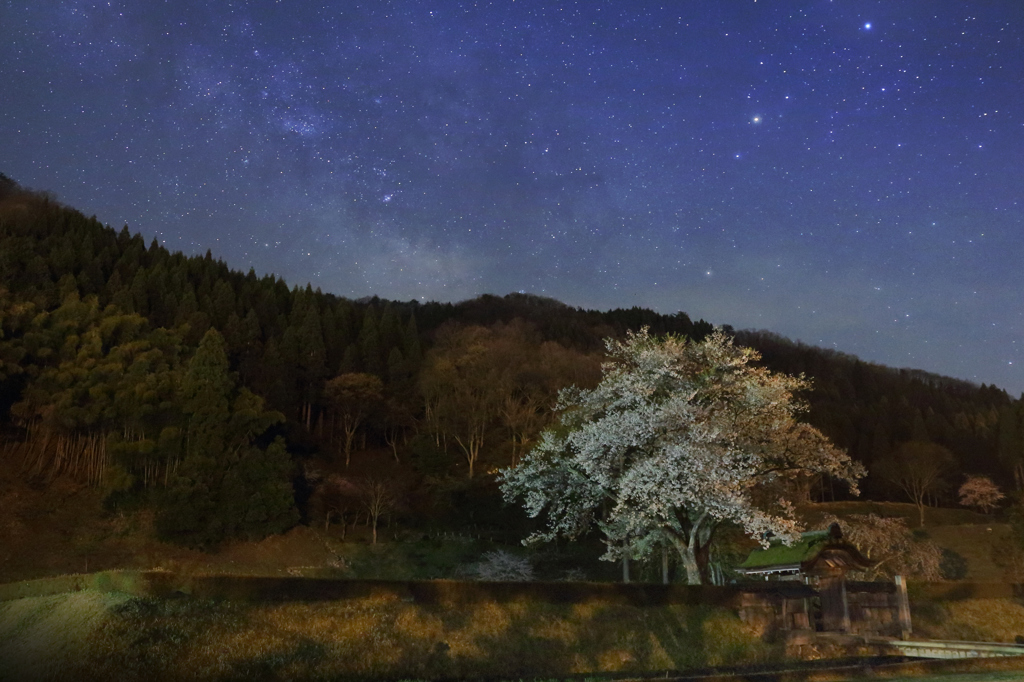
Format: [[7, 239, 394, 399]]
[[0, 571, 1024, 681]]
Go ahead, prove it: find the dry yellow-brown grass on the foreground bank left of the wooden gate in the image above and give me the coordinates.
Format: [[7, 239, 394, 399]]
[[0, 591, 781, 681]]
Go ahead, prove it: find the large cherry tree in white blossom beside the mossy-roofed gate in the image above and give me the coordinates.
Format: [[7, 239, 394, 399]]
[[499, 329, 864, 584]]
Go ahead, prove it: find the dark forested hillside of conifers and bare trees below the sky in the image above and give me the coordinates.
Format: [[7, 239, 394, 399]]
[[0, 175, 1024, 547]]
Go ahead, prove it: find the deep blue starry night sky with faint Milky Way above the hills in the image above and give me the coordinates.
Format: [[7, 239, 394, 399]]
[[0, 0, 1024, 395]]
